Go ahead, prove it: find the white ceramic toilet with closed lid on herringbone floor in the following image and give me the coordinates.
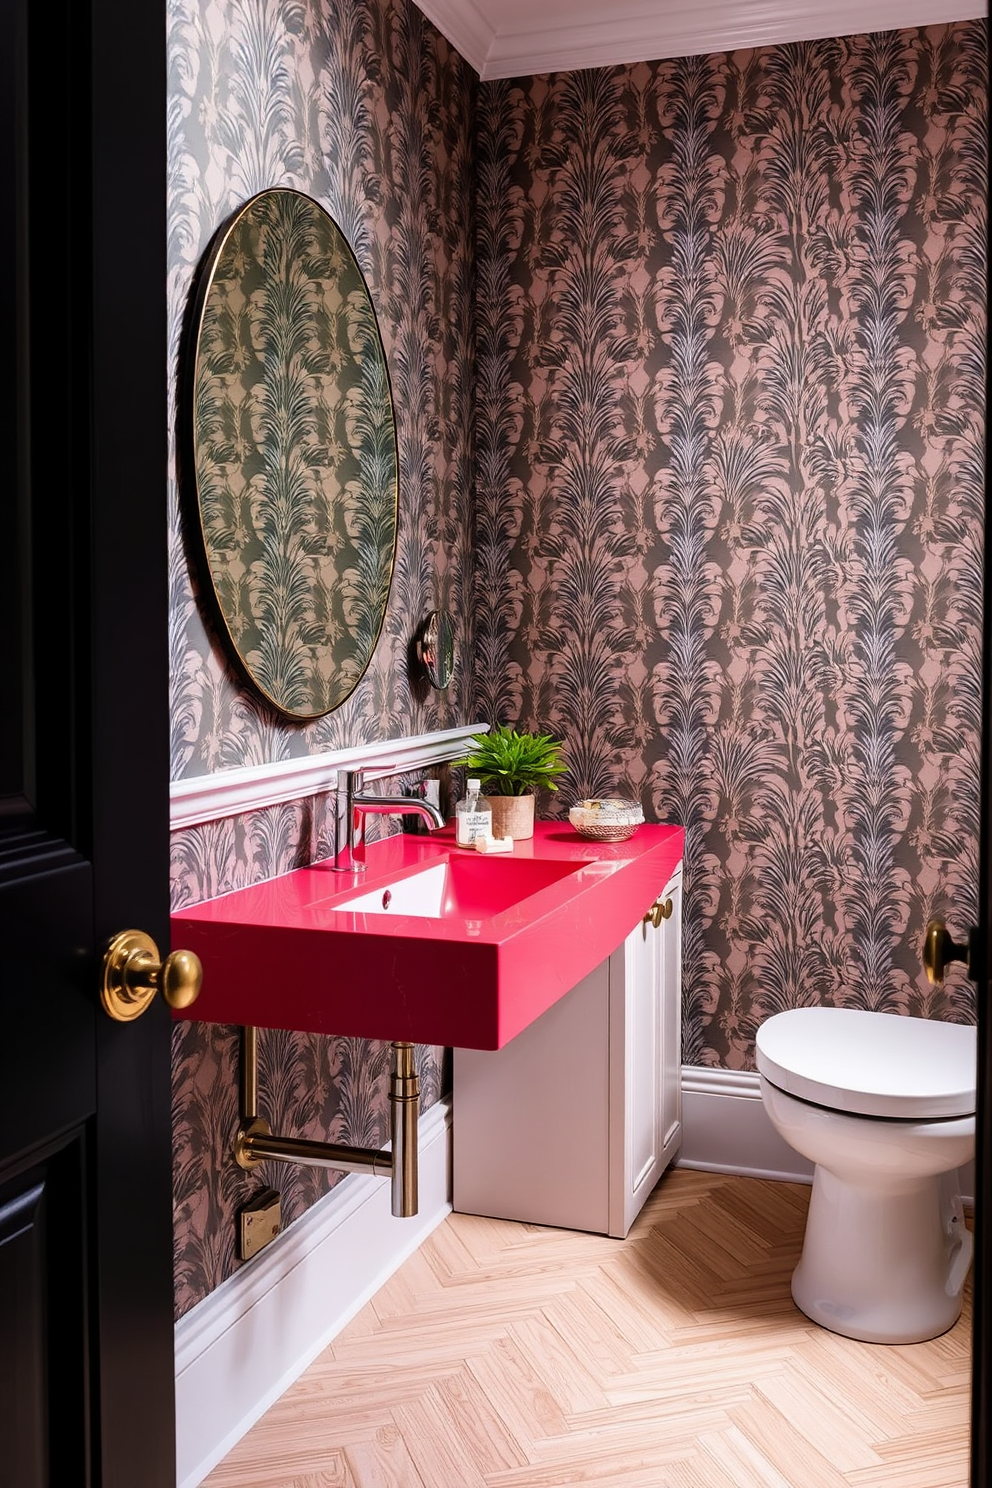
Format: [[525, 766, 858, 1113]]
[[757, 1007, 977, 1344]]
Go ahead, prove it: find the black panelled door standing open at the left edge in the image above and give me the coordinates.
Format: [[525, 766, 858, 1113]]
[[0, 0, 175, 1488]]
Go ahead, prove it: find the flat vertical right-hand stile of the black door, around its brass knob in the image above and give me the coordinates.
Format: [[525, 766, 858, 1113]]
[[88, 0, 175, 1470]]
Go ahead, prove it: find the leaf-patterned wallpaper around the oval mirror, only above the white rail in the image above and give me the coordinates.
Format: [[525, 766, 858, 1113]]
[[170, 0, 474, 780]]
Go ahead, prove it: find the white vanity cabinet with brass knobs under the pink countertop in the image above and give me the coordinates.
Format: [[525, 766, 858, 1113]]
[[452, 863, 681, 1235]]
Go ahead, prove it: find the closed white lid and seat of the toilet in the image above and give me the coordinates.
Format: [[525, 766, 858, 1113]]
[[757, 1007, 977, 1120]]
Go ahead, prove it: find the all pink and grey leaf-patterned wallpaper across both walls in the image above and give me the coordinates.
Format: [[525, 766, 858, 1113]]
[[170, 0, 988, 1312]]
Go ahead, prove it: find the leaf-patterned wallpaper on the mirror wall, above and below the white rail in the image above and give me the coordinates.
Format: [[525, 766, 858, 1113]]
[[170, 0, 476, 1314]]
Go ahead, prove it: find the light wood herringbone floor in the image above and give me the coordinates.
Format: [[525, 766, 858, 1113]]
[[205, 1168, 971, 1488]]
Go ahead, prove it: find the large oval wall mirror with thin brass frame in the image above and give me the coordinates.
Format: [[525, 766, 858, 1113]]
[[184, 189, 399, 719]]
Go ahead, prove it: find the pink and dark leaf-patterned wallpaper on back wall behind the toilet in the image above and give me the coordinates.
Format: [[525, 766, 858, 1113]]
[[476, 21, 988, 1068]]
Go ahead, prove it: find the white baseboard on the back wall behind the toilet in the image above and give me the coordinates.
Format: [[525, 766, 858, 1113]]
[[678, 1064, 974, 1204]]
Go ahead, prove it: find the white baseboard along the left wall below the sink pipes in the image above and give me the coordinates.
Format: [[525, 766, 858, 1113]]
[[175, 1101, 451, 1488]]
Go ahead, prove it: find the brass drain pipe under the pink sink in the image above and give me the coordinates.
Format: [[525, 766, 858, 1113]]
[[233, 1027, 421, 1219]]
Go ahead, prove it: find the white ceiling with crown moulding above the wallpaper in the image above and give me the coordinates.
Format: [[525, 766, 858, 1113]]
[[415, 0, 988, 79]]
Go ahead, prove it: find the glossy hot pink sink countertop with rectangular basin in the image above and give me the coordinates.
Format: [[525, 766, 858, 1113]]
[[173, 821, 684, 1049]]
